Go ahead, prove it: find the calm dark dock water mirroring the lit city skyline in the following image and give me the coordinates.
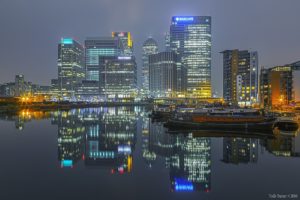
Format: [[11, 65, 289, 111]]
[[0, 107, 300, 200]]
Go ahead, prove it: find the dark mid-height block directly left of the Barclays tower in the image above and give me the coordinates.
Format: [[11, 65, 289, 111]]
[[149, 52, 180, 97]]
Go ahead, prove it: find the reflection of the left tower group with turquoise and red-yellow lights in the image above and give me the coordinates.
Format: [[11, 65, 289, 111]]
[[52, 107, 137, 174]]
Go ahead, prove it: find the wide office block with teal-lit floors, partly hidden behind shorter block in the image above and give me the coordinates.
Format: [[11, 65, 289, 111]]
[[84, 37, 121, 81]]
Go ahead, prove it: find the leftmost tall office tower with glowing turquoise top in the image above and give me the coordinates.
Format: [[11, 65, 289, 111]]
[[58, 38, 85, 97]]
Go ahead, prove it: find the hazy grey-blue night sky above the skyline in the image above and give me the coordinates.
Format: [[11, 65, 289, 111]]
[[0, 0, 300, 93]]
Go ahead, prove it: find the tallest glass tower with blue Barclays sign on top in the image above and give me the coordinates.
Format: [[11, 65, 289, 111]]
[[170, 16, 211, 98]]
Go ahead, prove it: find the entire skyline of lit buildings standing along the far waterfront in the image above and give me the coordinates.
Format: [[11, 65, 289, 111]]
[[0, 16, 300, 108]]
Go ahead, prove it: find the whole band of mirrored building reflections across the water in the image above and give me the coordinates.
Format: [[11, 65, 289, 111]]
[[0, 107, 300, 192]]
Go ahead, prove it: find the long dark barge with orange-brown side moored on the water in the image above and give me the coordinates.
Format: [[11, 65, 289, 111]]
[[165, 108, 275, 133]]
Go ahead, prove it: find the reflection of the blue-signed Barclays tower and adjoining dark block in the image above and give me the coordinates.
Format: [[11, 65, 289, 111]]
[[149, 123, 211, 192]]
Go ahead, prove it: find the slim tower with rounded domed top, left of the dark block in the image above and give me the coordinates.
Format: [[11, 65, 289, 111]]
[[142, 37, 158, 96]]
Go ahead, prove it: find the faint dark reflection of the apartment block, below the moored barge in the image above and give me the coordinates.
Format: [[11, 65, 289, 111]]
[[222, 138, 258, 164]]
